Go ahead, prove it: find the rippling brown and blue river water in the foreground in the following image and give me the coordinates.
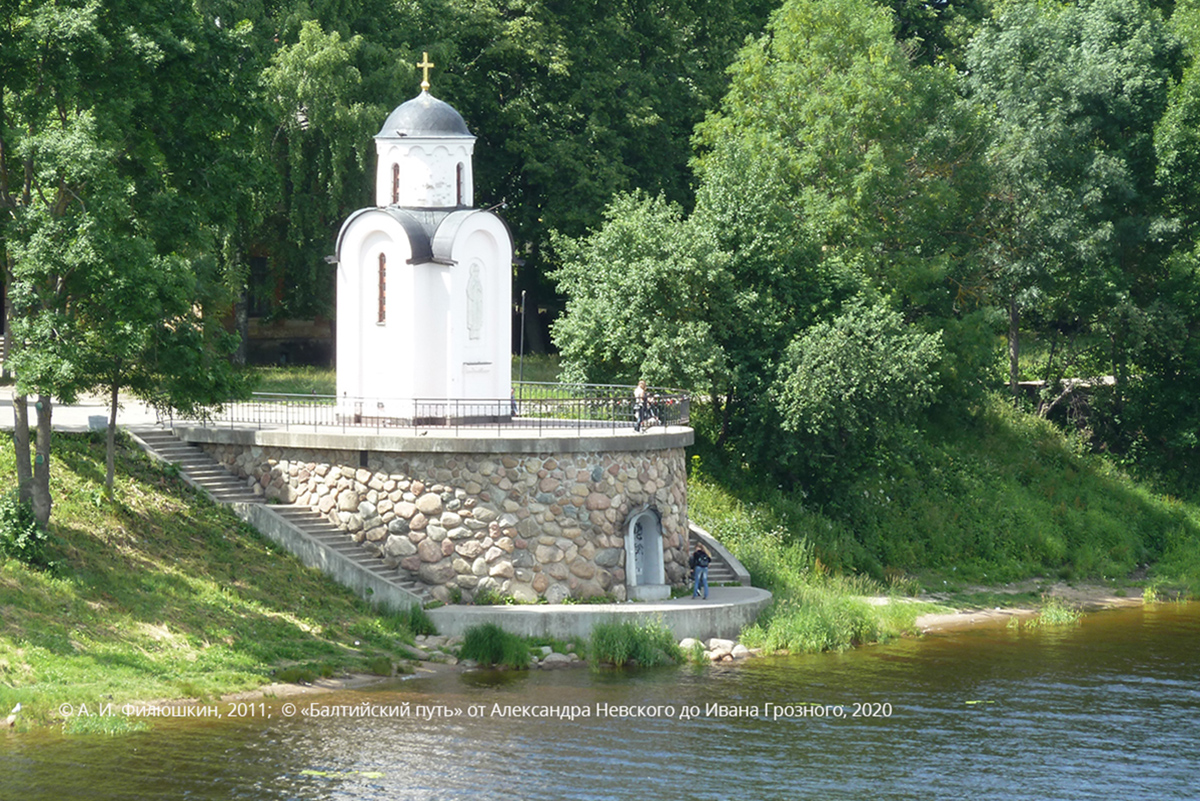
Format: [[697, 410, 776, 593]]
[[0, 603, 1200, 801]]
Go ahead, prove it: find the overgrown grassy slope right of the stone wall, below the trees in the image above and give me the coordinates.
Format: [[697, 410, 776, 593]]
[[689, 401, 1200, 650]]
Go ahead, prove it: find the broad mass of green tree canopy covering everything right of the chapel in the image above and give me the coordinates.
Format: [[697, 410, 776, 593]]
[[554, 0, 1200, 492]]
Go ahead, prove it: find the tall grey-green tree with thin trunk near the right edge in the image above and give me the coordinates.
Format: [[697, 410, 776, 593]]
[[967, 0, 1181, 403]]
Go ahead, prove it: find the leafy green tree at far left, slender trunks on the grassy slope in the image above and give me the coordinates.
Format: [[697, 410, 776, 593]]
[[0, 1, 255, 525]]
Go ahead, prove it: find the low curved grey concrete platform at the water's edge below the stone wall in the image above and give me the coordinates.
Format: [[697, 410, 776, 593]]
[[428, 586, 772, 639]]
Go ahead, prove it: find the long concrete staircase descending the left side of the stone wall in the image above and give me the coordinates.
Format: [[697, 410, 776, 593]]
[[127, 426, 431, 599]]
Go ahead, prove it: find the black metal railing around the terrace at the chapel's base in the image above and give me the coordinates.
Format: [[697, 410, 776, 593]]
[[174, 381, 691, 434]]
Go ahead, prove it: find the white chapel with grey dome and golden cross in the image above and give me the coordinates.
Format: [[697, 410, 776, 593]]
[[336, 54, 512, 421]]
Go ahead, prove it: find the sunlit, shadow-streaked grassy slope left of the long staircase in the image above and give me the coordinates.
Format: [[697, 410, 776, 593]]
[[0, 435, 424, 722]]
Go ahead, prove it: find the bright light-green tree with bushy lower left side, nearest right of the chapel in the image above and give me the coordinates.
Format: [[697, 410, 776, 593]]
[[554, 0, 982, 460]]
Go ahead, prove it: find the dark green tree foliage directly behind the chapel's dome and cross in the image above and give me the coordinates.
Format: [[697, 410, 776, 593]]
[[222, 0, 772, 342]]
